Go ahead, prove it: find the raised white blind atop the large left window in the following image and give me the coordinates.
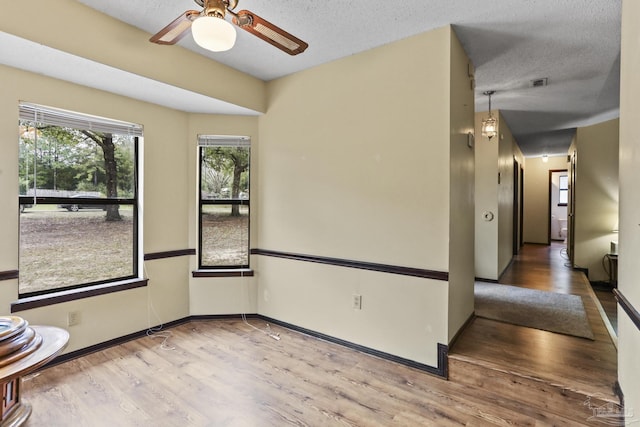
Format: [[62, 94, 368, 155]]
[[20, 102, 142, 136]]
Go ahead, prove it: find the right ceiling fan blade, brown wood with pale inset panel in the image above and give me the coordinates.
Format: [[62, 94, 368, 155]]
[[233, 10, 309, 55]]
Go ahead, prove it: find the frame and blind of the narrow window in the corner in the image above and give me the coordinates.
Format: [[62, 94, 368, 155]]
[[194, 135, 251, 270]]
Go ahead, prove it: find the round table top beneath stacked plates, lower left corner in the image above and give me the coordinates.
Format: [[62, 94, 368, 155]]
[[0, 326, 69, 383]]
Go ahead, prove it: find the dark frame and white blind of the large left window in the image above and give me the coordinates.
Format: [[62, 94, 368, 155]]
[[17, 102, 142, 298]]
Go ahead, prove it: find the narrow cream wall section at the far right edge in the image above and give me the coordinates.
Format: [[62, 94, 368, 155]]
[[618, 0, 640, 416]]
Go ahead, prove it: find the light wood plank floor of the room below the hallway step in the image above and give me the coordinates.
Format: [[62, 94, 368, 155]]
[[23, 320, 570, 427]]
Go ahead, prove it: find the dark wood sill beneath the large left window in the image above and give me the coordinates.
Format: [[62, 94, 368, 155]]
[[11, 279, 149, 313]]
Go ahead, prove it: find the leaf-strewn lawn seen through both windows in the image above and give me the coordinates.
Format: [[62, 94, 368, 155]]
[[19, 205, 249, 295]]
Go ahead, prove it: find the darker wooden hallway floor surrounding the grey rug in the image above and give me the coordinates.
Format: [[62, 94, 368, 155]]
[[449, 243, 619, 422]]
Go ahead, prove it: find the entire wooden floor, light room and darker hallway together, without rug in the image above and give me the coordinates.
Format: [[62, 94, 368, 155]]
[[22, 242, 616, 427]]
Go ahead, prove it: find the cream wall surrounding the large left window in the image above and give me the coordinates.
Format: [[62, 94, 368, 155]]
[[0, 66, 189, 351]]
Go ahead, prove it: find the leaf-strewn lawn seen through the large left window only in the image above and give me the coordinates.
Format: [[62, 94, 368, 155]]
[[19, 205, 134, 294]]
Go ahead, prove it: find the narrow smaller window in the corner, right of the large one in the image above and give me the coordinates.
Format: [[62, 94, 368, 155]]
[[198, 135, 251, 269]]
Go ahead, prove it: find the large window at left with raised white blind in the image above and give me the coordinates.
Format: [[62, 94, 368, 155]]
[[18, 103, 142, 297]]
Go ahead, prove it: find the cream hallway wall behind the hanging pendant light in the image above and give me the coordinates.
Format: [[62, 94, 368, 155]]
[[475, 111, 524, 280]]
